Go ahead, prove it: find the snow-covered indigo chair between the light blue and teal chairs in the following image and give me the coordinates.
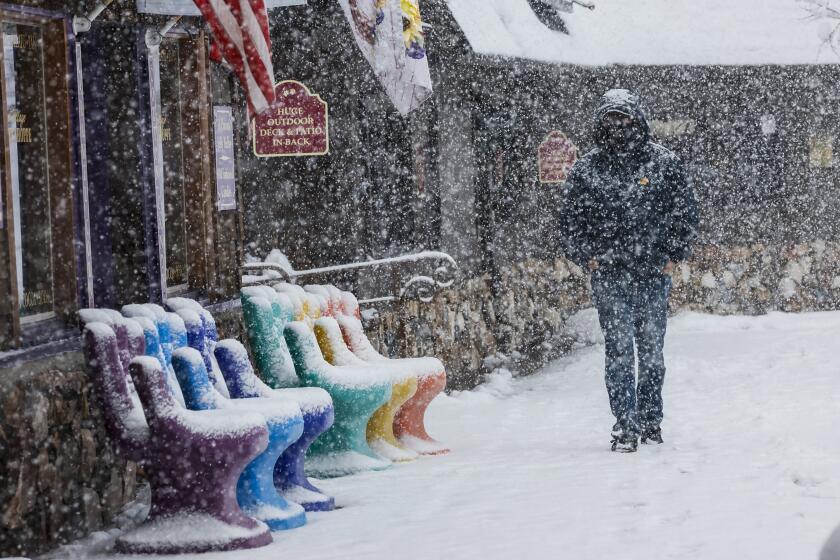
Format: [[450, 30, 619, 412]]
[[167, 298, 335, 511]]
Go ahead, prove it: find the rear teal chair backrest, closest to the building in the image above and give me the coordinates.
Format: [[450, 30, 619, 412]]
[[240, 288, 300, 389]]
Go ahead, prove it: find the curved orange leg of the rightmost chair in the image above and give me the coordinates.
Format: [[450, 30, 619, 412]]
[[394, 373, 449, 455]]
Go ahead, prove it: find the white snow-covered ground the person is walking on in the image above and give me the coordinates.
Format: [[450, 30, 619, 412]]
[[60, 313, 840, 560]]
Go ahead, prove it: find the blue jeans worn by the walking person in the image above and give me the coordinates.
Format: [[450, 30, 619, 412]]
[[592, 271, 671, 436]]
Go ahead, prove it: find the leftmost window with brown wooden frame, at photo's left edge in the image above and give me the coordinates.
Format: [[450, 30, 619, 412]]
[[0, 8, 76, 346]]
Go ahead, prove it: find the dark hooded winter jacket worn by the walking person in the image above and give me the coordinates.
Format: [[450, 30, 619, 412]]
[[560, 90, 698, 275]]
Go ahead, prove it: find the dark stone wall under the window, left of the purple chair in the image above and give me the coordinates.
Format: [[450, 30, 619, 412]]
[[0, 352, 136, 556]]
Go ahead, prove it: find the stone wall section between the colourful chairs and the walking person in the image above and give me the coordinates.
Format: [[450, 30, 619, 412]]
[[364, 260, 589, 389]]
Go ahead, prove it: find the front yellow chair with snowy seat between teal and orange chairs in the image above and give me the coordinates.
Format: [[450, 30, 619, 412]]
[[315, 317, 417, 461]]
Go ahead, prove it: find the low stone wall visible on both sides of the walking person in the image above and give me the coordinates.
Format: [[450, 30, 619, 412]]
[[365, 241, 840, 389]]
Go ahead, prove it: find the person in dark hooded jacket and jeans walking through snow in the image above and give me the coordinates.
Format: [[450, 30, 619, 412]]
[[560, 89, 698, 452]]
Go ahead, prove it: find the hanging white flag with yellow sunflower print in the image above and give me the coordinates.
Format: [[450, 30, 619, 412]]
[[339, 0, 432, 115]]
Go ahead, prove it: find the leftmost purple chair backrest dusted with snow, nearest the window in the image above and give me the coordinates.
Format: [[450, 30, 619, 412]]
[[83, 321, 149, 462]]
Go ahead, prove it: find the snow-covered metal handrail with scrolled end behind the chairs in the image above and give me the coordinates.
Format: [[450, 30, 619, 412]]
[[242, 251, 458, 304]]
